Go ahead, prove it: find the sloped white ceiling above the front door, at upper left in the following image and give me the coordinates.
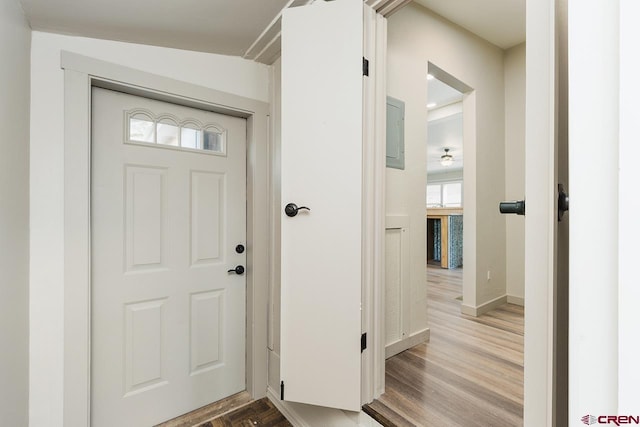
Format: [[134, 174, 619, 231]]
[[21, 0, 289, 56]]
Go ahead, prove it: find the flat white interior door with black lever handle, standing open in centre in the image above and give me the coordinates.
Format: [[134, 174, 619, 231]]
[[280, 0, 363, 411]]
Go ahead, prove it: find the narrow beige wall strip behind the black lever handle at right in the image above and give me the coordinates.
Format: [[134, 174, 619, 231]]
[[504, 43, 526, 303]]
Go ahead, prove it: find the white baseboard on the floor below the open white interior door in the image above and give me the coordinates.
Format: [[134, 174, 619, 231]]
[[267, 387, 382, 427]]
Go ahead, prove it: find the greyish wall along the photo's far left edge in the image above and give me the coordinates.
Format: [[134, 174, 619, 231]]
[[0, 0, 31, 426]]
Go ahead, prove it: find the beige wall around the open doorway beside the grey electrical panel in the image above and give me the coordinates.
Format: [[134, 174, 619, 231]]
[[387, 3, 506, 314]]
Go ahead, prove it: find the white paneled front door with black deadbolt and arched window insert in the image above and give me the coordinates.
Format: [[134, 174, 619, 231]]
[[91, 88, 246, 427]]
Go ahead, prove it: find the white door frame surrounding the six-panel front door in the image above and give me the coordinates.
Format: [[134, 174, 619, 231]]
[[61, 51, 270, 427]]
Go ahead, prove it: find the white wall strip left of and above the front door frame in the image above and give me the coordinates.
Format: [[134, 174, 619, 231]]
[[30, 32, 269, 426]]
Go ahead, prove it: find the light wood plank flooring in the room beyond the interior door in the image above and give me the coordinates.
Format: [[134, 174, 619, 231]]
[[364, 266, 524, 427]]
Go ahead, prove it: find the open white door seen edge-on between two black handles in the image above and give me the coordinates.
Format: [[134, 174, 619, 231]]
[[524, 0, 578, 426]]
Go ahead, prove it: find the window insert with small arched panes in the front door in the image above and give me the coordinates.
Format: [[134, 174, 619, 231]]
[[125, 109, 227, 155]]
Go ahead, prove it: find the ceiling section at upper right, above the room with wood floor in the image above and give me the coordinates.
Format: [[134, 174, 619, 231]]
[[413, 0, 526, 49]]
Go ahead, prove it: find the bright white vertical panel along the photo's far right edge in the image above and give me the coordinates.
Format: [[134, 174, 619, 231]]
[[568, 0, 624, 423]]
